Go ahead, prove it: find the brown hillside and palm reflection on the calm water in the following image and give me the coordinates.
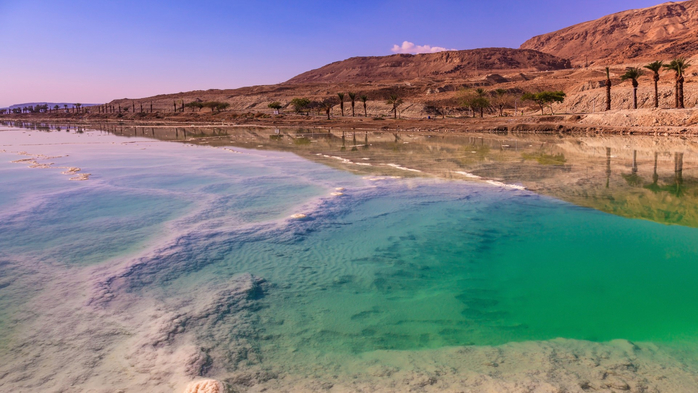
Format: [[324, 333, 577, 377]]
[[8, 121, 698, 227]]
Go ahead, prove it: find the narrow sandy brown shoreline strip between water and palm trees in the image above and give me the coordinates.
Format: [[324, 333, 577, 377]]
[[0, 108, 698, 136]]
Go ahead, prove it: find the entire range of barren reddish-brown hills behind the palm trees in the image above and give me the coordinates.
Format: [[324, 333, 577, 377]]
[[42, 0, 698, 118]]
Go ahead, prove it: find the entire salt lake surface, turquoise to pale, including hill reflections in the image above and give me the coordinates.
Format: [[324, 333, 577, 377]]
[[0, 124, 698, 392]]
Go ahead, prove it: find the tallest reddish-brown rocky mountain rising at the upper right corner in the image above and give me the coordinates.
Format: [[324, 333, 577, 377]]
[[521, 0, 698, 65]]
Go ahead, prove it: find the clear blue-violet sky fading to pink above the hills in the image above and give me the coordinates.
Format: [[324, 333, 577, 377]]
[[0, 0, 661, 107]]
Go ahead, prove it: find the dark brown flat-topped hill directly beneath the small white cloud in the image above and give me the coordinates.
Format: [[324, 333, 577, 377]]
[[286, 48, 571, 84]]
